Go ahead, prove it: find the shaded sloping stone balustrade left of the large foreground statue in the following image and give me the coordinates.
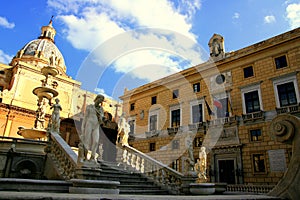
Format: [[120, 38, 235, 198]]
[[45, 132, 77, 180]]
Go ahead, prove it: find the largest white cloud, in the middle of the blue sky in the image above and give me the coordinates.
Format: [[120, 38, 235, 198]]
[[48, 0, 202, 85]]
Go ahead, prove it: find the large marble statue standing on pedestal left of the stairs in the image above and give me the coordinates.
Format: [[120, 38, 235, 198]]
[[79, 94, 104, 161]]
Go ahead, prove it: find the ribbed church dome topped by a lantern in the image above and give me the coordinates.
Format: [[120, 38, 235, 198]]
[[12, 20, 66, 75]]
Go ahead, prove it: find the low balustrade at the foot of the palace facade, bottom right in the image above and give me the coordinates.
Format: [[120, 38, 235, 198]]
[[226, 185, 274, 193]]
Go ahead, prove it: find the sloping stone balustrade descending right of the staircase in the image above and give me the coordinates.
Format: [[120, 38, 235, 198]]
[[120, 146, 184, 194]]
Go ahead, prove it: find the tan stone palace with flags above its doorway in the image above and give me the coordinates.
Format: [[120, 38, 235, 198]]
[[120, 28, 300, 185]]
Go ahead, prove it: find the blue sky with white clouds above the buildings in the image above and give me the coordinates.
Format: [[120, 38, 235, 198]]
[[0, 0, 300, 100]]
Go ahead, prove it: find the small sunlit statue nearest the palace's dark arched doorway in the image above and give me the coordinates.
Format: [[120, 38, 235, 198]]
[[194, 147, 207, 183]]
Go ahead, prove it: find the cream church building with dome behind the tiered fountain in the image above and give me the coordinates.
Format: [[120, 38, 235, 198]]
[[0, 20, 121, 146]]
